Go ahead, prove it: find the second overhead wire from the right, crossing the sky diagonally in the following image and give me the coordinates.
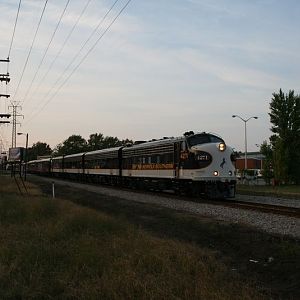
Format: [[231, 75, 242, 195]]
[[25, 0, 121, 124]]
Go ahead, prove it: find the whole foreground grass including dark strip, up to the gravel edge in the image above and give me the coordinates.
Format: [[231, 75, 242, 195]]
[[0, 177, 300, 299]]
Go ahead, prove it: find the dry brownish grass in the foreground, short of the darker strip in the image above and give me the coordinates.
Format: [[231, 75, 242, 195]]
[[0, 176, 263, 299]]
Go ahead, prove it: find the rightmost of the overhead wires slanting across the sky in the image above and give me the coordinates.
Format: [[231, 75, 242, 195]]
[[25, 0, 132, 125]]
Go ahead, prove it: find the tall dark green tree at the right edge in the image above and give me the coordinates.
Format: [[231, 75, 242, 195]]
[[269, 89, 300, 183]]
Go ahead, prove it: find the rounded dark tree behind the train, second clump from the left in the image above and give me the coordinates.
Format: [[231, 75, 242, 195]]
[[54, 134, 88, 156]]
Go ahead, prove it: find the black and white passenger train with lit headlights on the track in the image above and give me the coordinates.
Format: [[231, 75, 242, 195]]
[[27, 131, 236, 198]]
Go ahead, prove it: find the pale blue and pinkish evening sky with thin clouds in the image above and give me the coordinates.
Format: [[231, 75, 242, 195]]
[[0, 0, 300, 151]]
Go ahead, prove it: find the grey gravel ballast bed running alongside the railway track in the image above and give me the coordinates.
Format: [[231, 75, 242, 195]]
[[38, 178, 300, 238]]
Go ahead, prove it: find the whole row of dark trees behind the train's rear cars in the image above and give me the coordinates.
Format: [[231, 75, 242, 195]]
[[27, 133, 133, 160]]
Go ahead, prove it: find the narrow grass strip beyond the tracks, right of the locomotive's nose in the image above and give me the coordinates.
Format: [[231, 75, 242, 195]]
[[237, 184, 300, 200]]
